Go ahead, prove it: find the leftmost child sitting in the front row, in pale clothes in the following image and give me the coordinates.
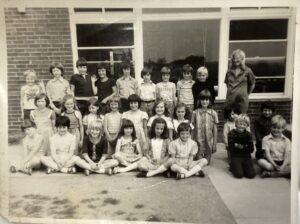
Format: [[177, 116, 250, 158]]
[[10, 119, 45, 175]]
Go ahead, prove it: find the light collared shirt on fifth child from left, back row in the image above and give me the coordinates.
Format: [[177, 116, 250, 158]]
[[116, 76, 138, 99]]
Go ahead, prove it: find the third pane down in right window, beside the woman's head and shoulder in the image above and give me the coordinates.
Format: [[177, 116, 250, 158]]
[[246, 59, 286, 77]]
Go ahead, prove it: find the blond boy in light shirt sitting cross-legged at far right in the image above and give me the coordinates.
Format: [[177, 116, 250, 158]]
[[258, 115, 291, 177]]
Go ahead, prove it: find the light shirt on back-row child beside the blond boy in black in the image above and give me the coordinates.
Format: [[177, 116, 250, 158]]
[[177, 80, 195, 104]]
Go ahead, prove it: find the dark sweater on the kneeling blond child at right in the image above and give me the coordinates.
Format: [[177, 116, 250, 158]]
[[228, 129, 254, 158]]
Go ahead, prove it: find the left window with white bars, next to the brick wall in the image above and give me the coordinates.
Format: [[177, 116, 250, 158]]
[[76, 23, 134, 78]]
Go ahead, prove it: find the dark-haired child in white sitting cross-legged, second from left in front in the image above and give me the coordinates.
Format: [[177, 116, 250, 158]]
[[41, 116, 80, 174]]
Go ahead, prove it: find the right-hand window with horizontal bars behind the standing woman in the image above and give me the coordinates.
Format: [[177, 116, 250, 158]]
[[229, 19, 288, 93]]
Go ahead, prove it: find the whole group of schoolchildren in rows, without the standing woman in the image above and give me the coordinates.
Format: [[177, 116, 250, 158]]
[[10, 58, 291, 179]]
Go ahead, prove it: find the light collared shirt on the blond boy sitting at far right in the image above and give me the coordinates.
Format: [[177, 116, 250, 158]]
[[262, 134, 291, 161]]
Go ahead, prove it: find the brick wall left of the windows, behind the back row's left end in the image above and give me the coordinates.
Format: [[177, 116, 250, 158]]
[[5, 8, 73, 133]]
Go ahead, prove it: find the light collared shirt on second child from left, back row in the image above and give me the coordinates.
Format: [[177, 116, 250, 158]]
[[46, 77, 71, 101]]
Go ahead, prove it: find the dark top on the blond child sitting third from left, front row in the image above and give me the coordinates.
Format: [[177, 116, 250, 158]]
[[82, 136, 107, 162]]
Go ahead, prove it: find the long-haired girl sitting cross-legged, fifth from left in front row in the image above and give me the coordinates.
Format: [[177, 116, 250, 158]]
[[137, 117, 171, 177]]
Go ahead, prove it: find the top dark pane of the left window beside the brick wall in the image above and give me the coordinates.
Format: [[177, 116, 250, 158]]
[[76, 23, 134, 47]]
